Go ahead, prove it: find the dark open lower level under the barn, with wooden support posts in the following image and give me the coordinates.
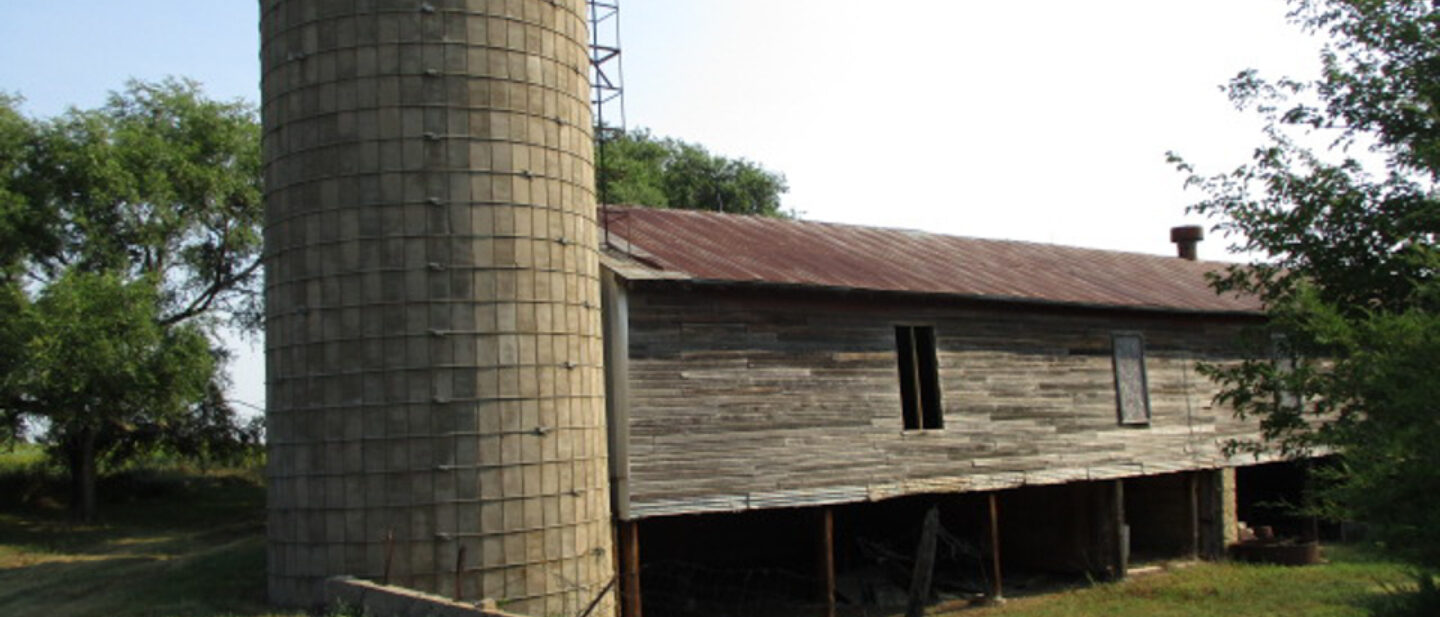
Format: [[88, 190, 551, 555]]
[[616, 463, 1338, 617]]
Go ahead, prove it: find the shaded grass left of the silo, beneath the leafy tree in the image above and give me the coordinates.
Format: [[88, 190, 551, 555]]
[[0, 447, 302, 617]]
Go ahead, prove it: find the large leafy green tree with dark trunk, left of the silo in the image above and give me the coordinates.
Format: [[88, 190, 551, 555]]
[[0, 79, 264, 518]]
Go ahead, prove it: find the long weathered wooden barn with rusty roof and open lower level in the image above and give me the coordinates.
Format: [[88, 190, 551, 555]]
[[599, 206, 1290, 616]]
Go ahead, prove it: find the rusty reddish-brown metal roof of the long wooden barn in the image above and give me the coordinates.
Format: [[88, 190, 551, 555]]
[[600, 206, 1259, 313]]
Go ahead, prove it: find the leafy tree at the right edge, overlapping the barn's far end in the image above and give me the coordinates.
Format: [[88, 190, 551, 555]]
[[1172, 0, 1440, 580]]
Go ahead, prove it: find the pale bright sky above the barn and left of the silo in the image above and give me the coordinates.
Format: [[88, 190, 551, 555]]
[[0, 0, 1319, 415]]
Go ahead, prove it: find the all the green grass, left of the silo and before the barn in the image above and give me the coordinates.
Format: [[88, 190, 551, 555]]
[[0, 447, 1424, 617]]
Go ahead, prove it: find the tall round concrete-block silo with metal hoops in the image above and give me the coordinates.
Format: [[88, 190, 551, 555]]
[[261, 0, 612, 616]]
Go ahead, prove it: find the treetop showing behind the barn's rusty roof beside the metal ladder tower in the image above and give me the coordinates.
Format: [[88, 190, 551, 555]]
[[595, 128, 792, 216]]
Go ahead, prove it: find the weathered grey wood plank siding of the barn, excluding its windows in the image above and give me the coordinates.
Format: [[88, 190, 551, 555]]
[[628, 284, 1251, 518]]
